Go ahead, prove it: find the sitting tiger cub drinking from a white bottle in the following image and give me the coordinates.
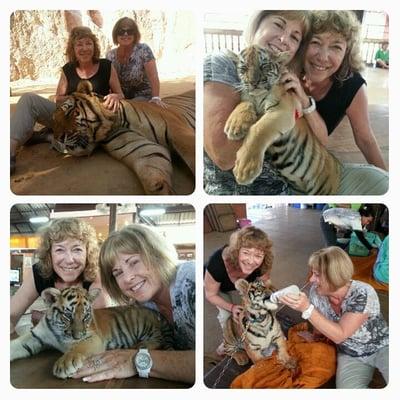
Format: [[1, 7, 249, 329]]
[[223, 279, 297, 369]]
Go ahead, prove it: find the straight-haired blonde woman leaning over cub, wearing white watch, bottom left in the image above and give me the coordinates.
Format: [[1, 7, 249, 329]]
[[75, 224, 195, 383]]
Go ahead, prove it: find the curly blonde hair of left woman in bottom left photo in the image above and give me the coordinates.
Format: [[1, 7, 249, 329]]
[[36, 218, 99, 282]]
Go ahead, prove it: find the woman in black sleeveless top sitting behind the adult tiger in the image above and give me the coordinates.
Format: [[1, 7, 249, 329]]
[[10, 26, 124, 174]]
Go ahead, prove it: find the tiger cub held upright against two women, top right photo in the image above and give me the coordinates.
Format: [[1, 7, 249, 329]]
[[224, 45, 341, 195]]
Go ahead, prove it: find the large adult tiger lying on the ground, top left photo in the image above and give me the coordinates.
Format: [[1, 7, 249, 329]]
[[53, 81, 195, 194]]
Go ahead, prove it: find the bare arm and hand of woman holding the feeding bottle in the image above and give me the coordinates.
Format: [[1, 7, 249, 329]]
[[279, 293, 368, 344]]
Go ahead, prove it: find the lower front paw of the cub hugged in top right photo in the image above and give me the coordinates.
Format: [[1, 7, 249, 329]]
[[233, 146, 264, 185]]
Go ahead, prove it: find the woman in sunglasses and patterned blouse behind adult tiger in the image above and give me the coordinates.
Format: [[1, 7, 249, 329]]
[[106, 17, 165, 107]]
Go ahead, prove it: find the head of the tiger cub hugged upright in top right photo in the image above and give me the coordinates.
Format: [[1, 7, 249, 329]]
[[237, 45, 289, 91]]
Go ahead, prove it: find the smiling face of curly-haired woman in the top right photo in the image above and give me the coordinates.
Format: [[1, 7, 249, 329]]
[[304, 32, 347, 83]]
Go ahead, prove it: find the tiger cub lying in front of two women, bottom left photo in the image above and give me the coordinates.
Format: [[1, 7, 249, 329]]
[[10, 286, 173, 378]]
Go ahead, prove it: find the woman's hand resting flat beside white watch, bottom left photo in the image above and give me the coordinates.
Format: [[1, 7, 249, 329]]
[[73, 349, 137, 382]]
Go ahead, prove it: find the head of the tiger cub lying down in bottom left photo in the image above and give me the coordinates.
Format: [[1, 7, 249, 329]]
[[41, 286, 100, 340]]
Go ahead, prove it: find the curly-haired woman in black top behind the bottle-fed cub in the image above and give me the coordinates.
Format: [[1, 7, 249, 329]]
[[204, 226, 273, 355]]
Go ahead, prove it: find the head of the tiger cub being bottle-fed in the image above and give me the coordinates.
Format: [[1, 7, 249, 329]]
[[235, 279, 278, 314]]
